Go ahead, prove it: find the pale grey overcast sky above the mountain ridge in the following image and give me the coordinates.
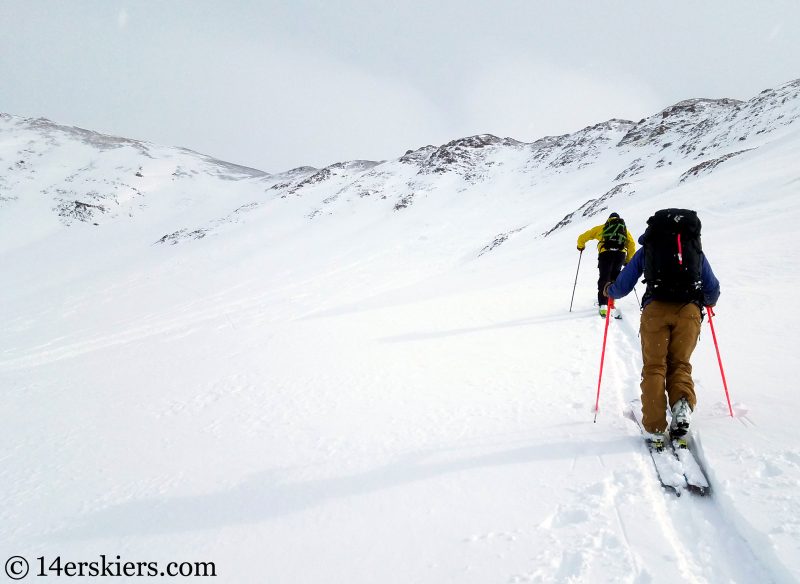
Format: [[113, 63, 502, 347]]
[[0, 0, 800, 172]]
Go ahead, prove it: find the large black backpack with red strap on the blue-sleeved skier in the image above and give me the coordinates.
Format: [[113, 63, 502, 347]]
[[643, 209, 703, 304]]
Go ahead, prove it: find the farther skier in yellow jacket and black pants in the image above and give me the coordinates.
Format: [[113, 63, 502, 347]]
[[578, 213, 636, 318]]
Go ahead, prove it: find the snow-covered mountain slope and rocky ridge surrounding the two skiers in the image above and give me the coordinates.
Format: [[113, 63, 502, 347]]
[[0, 82, 800, 584]]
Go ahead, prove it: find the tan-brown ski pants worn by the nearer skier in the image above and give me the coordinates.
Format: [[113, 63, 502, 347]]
[[639, 300, 700, 432]]
